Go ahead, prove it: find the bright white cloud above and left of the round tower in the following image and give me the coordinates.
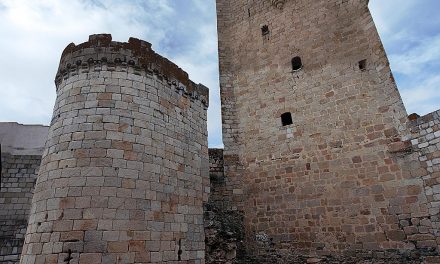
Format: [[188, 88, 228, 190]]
[[0, 0, 169, 121]]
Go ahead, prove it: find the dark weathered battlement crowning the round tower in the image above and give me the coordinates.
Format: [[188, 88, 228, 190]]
[[55, 34, 209, 107]]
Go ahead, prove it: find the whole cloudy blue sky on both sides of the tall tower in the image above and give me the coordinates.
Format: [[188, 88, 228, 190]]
[[0, 0, 440, 147]]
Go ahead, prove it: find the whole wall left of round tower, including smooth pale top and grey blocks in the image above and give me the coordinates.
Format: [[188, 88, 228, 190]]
[[0, 123, 48, 263]]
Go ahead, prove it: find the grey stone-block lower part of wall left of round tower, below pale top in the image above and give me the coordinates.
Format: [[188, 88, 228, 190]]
[[0, 153, 41, 263]]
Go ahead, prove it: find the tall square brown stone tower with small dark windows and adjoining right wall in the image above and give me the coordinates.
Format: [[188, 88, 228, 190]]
[[217, 0, 440, 263]]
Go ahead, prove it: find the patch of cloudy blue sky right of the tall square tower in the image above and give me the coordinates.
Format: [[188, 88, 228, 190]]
[[370, 0, 440, 115]]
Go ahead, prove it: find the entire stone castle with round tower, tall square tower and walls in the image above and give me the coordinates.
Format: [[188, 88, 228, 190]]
[[0, 0, 440, 264]]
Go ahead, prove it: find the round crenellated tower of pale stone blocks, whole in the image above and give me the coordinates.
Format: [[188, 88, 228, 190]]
[[21, 35, 209, 264]]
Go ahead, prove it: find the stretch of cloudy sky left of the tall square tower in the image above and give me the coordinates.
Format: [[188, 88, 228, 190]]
[[0, 0, 221, 146]]
